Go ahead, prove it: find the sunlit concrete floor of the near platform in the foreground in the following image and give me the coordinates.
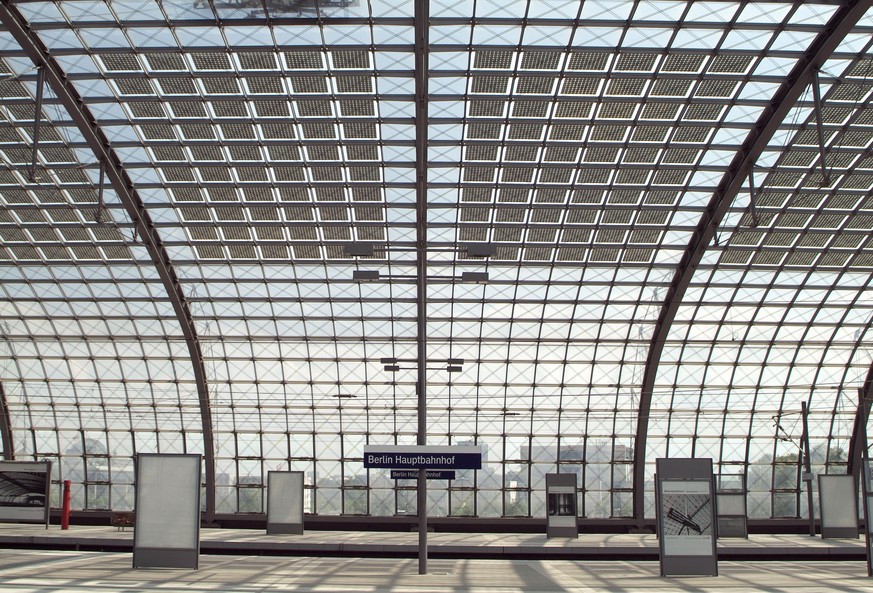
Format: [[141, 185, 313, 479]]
[[0, 550, 873, 593]]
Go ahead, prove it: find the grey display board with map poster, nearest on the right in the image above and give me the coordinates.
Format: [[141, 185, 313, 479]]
[[655, 458, 718, 576]]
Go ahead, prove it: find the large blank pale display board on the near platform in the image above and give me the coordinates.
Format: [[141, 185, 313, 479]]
[[133, 453, 201, 569]]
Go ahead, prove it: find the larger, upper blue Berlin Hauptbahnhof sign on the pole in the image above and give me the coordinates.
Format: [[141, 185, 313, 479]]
[[364, 445, 482, 469]]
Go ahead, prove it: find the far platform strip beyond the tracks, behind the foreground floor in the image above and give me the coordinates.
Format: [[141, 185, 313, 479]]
[[0, 524, 866, 563]]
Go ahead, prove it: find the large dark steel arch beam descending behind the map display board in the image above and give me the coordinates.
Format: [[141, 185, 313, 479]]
[[633, 0, 873, 526]]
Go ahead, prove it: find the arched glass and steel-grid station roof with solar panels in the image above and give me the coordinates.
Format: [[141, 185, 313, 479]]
[[0, 0, 873, 520]]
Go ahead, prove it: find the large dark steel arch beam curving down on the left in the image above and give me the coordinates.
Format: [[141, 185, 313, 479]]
[[0, 0, 215, 523]]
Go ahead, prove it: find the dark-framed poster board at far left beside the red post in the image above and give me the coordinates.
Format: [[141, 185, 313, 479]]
[[0, 461, 52, 527]]
